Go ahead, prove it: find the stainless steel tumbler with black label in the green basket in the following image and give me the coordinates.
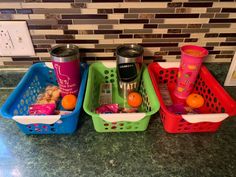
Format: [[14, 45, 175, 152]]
[[116, 44, 143, 97]]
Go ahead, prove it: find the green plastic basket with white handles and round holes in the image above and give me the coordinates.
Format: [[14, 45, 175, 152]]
[[83, 61, 160, 132]]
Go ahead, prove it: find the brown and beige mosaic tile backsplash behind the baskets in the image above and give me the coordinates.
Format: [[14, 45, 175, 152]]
[[0, 0, 236, 65]]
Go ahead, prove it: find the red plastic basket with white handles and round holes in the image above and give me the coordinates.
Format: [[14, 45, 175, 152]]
[[148, 62, 236, 133]]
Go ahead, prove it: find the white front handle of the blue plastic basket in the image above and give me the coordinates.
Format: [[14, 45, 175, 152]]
[[13, 115, 61, 125]]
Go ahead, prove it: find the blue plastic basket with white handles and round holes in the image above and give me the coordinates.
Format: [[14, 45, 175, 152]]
[[0, 63, 88, 134]]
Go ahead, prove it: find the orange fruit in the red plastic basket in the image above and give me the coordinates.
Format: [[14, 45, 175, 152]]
[[186, 93, 204, 108]]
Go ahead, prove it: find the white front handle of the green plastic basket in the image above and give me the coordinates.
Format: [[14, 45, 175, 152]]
[[99, 113, 146, 122]]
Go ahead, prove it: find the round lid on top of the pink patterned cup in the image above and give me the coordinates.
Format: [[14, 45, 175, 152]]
[[180, 45, 208, 58]]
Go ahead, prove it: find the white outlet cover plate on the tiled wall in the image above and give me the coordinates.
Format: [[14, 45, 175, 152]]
[[0, 21, 35, 56]]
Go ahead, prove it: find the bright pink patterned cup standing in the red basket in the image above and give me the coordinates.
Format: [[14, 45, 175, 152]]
[[174, 45, 208, 99]]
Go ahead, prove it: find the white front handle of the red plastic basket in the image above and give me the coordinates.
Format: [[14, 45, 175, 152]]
[[182, 113, 229, 123]]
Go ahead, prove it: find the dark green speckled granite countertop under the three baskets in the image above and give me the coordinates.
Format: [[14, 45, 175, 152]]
[[0, 64, 236, 177]]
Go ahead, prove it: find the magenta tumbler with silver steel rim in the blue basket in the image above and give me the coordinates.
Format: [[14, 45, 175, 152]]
[[50, 44, 80, 97]]
